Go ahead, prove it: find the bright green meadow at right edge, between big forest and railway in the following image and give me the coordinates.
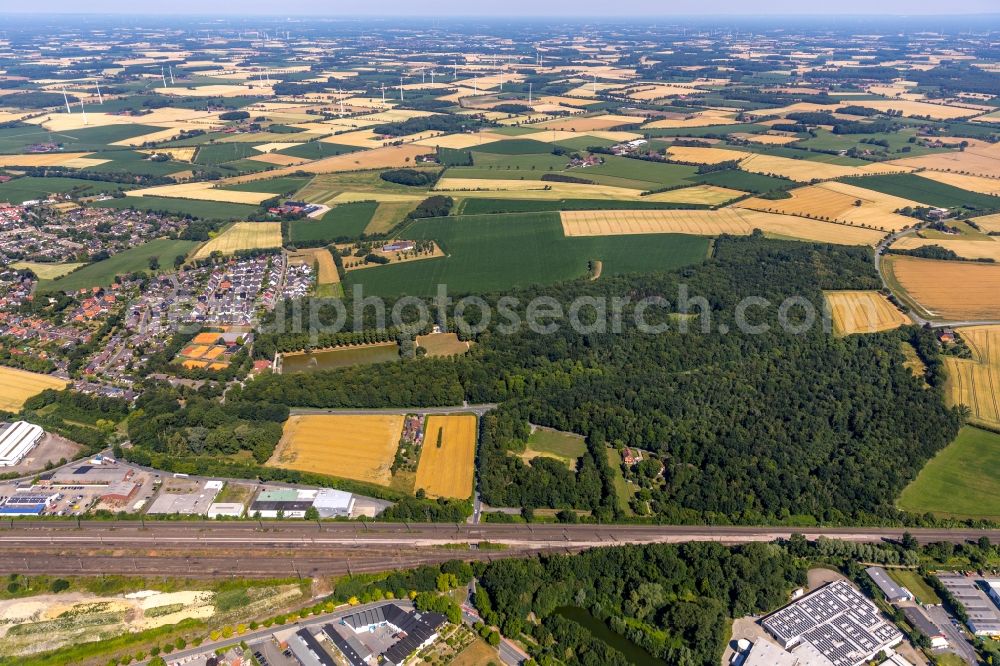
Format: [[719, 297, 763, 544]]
[[896, 426, 1000, 520]]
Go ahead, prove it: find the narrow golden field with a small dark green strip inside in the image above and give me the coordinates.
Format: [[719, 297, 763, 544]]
[[414, 415, 476, 499]]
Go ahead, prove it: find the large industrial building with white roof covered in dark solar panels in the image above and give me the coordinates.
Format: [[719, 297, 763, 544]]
[[761, 580, 903, 666]]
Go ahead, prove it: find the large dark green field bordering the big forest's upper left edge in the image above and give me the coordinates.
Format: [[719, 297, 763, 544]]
[[345, 212, 709, 296]]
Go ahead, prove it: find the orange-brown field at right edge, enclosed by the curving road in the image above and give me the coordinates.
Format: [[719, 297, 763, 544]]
[[884, 256, 1000, 320]]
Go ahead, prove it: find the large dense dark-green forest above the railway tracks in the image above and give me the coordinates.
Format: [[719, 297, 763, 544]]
[[232, 236, 960, 522]]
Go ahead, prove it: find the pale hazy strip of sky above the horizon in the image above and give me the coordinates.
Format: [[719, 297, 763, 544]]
[[0, 0, 1000, 18]]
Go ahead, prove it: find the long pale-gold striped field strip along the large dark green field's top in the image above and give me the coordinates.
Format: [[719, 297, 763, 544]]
[[560, 208, 882, 246]]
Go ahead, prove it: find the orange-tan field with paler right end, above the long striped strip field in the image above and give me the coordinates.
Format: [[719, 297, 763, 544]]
[[735, 181, 919, 231]]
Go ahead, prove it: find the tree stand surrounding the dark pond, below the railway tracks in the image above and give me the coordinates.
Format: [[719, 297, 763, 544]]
[[475, 543, 805, 666]]
